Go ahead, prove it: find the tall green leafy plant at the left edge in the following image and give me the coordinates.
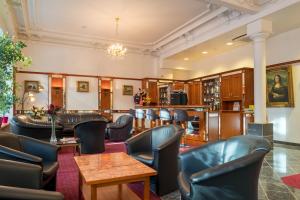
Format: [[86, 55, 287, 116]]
[[0, 34, 31, 126]]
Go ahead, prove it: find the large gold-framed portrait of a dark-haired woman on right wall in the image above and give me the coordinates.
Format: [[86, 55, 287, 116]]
[[267, 65, 294, 107]]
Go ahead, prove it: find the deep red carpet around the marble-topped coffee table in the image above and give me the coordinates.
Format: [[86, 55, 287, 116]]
[[56, 142, 160, 200]]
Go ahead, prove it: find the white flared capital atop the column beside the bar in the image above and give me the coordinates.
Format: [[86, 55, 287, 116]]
[[247, 19, 272, 41]]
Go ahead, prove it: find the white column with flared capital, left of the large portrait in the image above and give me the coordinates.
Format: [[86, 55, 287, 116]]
[[247, 20, 272, 123]]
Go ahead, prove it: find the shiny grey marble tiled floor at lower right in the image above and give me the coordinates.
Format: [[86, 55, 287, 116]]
[[161, 144, 300, 200]]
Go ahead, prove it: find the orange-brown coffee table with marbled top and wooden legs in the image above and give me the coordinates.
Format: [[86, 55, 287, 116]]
[[74, 152, 157, 200]]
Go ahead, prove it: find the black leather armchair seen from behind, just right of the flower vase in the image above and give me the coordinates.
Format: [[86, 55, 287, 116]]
[[74, 120, 107, 154]]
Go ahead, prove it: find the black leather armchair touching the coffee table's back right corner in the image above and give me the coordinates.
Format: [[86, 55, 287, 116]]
[[125, 125, 184, 196]]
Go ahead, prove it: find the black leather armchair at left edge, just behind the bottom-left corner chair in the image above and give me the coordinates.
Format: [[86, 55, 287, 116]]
[[0, 133, 59, 190]]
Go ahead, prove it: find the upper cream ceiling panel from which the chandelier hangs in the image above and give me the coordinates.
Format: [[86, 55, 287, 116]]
[[8, 0, 212, 45]]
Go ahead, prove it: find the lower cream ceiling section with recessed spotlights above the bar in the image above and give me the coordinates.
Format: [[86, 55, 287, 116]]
[[165, 3, 300, 66]]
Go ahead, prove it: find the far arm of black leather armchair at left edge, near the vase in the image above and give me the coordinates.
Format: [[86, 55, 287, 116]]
[[19, 135, 59, 161]]
